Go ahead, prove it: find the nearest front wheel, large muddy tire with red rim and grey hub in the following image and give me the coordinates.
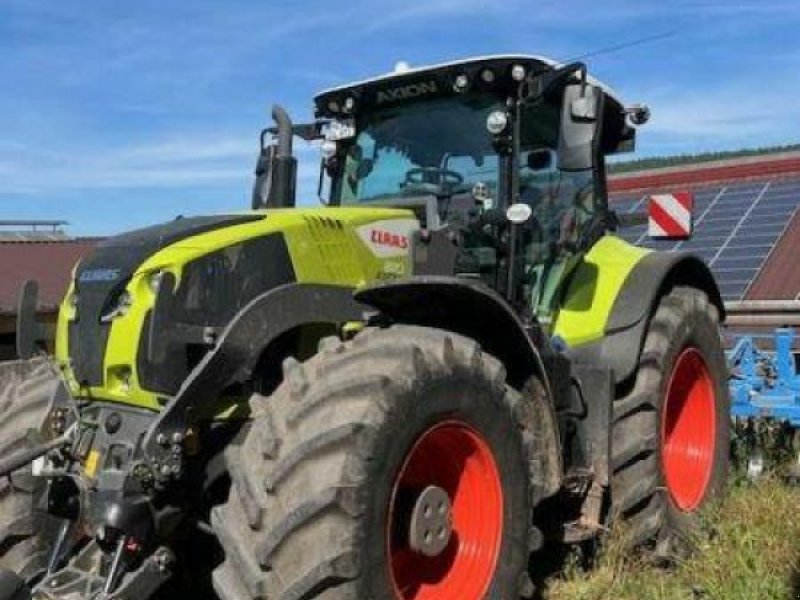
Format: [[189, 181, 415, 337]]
[[212, 326, 538, 600]]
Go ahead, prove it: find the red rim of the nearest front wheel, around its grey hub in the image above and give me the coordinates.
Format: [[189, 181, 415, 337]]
[[387, 421, 503, 600]]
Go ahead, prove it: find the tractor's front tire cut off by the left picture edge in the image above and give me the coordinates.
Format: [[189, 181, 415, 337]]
[[0, 359, 58, 579]]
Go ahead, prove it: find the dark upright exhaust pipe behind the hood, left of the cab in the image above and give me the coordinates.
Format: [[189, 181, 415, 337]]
[[253, 104, 297, 209]]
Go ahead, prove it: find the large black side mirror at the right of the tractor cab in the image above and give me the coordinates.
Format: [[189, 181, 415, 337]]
[[558, 84, 603, 171]]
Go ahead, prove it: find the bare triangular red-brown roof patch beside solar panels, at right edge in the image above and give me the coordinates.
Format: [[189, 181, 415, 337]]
[[745, 209, 800, 300]]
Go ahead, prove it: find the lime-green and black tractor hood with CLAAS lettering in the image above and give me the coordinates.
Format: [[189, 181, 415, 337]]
[[56, 207, 419, 410]]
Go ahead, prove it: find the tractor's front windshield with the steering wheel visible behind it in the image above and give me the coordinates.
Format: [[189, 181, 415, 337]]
[[334, 94, 502, 204]]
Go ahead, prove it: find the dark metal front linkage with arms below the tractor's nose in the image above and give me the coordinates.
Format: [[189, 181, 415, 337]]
[[0, 384, 177, 600]]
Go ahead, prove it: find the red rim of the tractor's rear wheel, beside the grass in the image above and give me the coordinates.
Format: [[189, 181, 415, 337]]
[[661, 347, 717, 512]]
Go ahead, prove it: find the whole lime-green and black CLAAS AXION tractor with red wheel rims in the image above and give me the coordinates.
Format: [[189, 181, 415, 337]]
[[0, 56, 729, 600]]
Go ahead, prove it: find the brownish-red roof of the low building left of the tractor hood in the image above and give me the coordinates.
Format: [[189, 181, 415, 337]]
[[0, 238, 100, 313]]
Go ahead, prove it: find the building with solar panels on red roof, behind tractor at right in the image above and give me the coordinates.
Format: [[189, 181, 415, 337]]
[[609, 152, 800, 344]]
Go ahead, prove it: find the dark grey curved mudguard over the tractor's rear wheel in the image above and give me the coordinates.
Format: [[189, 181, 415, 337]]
[[570, 252, 725, 383]]
